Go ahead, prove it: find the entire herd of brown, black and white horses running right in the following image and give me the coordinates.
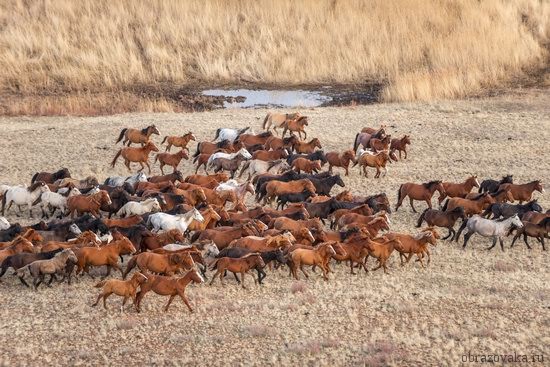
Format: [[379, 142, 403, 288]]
[[0, 113, 550, 312]]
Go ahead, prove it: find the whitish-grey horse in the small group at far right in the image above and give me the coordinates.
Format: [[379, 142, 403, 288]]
[[457, 214, 523, 251]]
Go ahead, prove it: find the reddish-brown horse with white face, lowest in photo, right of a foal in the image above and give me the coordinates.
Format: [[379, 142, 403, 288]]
[[135, 269, 204, 312]]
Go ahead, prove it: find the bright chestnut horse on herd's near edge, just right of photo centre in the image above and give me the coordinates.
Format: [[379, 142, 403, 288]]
[[289, 242, 336, 281]]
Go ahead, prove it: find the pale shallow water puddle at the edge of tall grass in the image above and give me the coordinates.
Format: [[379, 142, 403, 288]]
[[202, 89, 332, 108]]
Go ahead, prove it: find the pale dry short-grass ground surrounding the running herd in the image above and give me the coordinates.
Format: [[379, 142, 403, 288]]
[[0, 91, 550, 366]]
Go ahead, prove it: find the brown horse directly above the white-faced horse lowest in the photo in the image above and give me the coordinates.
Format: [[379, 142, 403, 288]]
[[122, 252, 195, 279]]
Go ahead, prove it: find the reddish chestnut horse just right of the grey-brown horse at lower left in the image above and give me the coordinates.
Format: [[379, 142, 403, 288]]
[[75, 238, 136, 276]]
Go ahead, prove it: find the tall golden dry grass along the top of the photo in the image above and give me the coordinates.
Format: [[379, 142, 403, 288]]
[[0, 0, 550, 114]]
